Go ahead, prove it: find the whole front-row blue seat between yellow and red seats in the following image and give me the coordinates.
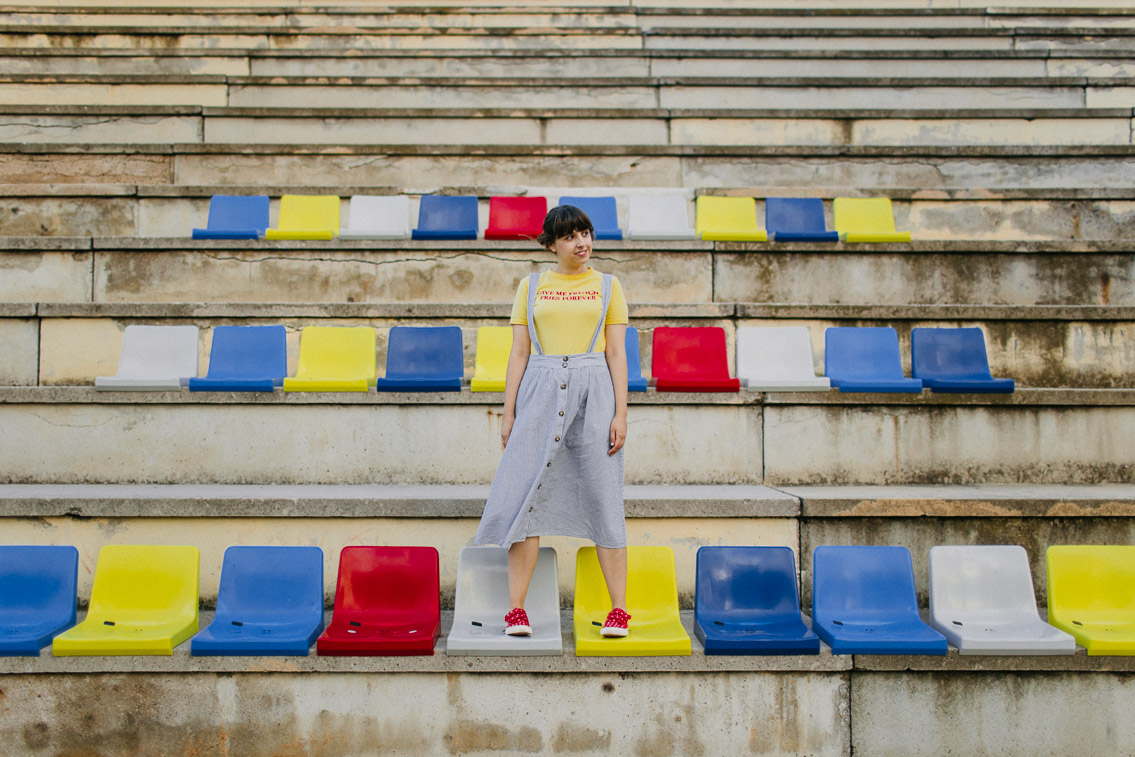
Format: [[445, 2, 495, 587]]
[[190, 547, 323, 657]]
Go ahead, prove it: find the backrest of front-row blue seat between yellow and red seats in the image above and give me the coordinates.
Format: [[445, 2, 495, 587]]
[[217, 547, 323, 622]]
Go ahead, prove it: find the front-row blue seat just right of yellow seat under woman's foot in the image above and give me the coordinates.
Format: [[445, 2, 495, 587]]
[[693, 547, 819, 655]]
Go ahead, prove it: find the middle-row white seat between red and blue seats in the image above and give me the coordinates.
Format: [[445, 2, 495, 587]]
[[737, 326, 832, 392]]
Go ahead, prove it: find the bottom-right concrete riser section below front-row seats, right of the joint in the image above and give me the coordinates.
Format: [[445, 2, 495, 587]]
[[851, 673, 1135, 757]]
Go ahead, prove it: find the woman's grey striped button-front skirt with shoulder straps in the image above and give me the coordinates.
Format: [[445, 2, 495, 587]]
[[473, 274, 627, 547]]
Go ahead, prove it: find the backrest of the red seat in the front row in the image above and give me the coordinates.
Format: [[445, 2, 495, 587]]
[[335, 546, 440, 623]]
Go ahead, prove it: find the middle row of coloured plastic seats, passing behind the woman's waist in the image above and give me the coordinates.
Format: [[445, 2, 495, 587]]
[[94, 325, 1015, 393]]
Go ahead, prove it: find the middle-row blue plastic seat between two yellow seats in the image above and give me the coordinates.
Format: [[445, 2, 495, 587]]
[[376, 326, 465, 392]]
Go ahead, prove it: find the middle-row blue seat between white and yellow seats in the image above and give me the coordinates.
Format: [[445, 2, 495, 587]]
[[190, 326, 287, 392]]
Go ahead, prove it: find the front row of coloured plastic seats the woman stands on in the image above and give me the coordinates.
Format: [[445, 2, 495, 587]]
[[0, 545, 1135, 656]]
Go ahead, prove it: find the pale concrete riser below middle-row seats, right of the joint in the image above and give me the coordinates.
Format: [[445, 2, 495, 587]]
[[765, 406, 1135, 487]]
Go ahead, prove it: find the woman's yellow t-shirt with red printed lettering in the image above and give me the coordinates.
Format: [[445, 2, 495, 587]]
[[511, 268, 627, 355]]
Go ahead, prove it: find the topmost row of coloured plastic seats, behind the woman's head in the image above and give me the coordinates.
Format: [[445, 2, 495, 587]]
[[193, 194, 910, 242]]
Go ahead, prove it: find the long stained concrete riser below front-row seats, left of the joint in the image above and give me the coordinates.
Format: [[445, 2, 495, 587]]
[[0, 673, 851, 757]]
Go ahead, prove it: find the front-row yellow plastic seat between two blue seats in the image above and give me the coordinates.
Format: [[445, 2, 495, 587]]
[[51, 545, 201, 657]]
